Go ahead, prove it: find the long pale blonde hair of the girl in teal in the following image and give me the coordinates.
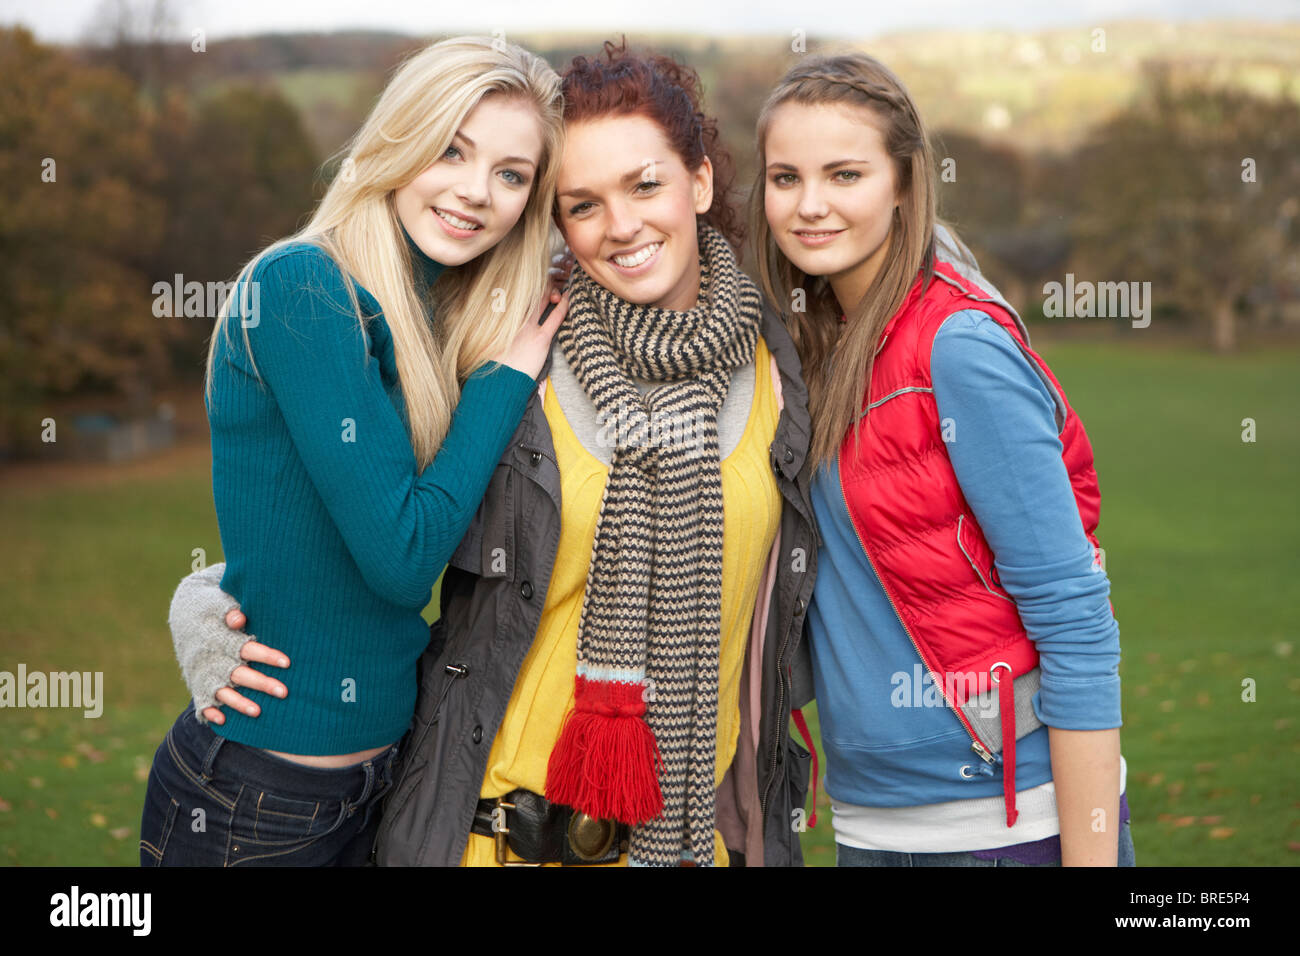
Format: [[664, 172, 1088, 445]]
[[205, 36, 563, 468]]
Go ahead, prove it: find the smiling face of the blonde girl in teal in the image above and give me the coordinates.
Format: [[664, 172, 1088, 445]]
[[394, 94, 542, 265]]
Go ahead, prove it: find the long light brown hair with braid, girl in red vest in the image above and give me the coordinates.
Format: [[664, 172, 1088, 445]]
[[750, 53, 936, 466]]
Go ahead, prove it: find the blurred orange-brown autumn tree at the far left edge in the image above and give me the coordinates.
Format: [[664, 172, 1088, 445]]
[[0, 27, 168, 445]]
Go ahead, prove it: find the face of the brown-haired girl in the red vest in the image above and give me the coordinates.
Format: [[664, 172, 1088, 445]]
[[763, 103, 900, 311]]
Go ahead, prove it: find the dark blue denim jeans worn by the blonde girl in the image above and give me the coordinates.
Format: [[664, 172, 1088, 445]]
[[140, 702, 398, 866]]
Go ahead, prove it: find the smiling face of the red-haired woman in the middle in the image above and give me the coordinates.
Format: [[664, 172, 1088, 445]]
[[556, 116, 714, 311]]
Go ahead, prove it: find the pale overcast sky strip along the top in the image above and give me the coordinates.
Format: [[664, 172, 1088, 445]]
[[0, 0, 1300, 42]]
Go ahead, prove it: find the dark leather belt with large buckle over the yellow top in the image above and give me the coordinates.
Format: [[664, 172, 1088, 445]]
[[471, 790, 628, 866]]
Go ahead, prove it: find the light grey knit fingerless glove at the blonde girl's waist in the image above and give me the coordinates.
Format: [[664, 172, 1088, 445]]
[[166, 562, 255, 723]]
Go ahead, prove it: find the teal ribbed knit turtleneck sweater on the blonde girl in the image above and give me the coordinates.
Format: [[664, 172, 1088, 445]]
[[208, 230, 536, 754]]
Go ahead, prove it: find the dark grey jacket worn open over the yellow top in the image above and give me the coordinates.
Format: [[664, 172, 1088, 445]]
[[376, 306, 818, 866]]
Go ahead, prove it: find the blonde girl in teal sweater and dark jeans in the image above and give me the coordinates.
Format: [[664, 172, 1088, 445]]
[[140, 38, 566, 865]]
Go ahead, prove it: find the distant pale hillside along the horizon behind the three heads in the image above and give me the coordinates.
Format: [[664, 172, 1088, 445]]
[[68, 21, 1300, 153]]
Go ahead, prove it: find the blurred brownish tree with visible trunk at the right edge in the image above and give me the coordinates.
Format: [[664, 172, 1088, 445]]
[[1075, 66, 1300, 351]]
